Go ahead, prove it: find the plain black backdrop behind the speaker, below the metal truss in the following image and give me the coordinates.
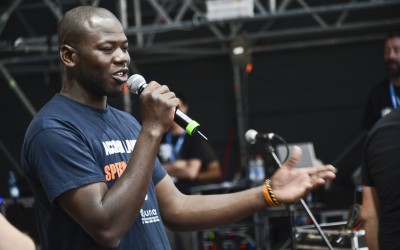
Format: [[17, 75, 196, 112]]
[[0, 41, 386, 203]]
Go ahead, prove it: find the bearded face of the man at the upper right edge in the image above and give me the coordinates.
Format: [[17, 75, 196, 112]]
[[384, 37, 400, 77]]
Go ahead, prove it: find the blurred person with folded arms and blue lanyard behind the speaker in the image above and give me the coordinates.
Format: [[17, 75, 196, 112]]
[[158, 94, 221, 250]]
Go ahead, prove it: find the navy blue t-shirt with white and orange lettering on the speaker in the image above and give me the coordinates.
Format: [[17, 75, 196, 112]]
[[21, 94, 170, 250]]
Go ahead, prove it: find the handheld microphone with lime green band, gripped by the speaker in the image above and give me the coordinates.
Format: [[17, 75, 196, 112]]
[[127, 74, 208, 140]]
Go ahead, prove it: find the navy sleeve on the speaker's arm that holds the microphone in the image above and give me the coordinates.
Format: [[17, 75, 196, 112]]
[[30, 129, 105, 202]]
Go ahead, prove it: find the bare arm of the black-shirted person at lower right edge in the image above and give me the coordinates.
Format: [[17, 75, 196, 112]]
[[361, 186, 379, 250]]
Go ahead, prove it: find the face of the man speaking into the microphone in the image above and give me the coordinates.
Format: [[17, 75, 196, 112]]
[[75, 14, 130, 96]]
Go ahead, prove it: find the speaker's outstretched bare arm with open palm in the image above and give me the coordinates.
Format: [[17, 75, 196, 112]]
[[156, 147, 335, 231]]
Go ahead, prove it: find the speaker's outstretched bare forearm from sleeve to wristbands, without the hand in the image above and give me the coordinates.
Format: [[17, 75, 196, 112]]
[[156, 176, 267, 231]]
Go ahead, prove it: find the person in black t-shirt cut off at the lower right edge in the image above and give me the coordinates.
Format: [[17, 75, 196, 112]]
[[361, 109, 400, 250]]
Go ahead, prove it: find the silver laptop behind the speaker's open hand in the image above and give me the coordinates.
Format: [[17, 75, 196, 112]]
[[275, 142, 318, 168]]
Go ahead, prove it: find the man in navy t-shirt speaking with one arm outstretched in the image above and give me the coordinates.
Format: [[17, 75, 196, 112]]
[[21, 6, 335, 250]]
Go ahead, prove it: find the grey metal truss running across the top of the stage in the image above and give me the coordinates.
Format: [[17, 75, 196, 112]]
[[0, 0, 400, 69]]
